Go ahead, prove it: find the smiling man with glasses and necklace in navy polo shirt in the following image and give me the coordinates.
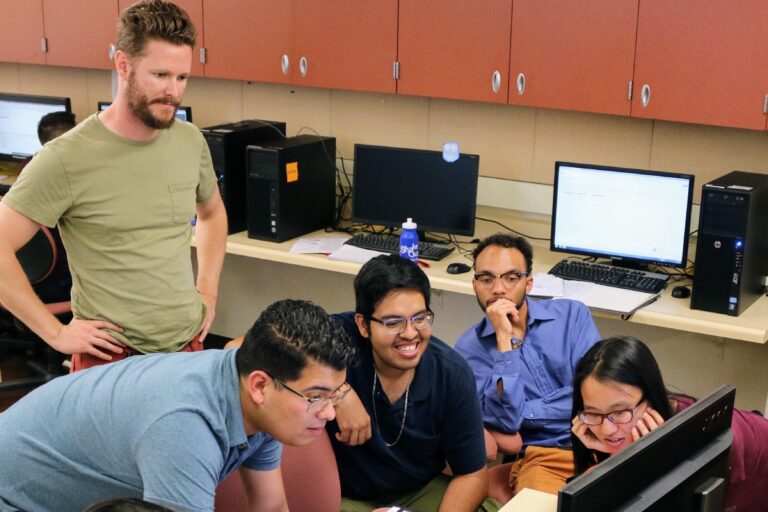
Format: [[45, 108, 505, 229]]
[[327, 255, 497, 512]]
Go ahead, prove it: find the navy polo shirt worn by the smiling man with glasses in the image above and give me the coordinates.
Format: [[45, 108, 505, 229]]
[[326, 313, 486, 500]]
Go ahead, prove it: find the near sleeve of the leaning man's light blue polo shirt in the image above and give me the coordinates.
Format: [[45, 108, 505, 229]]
[[135, 411, 224, 512]]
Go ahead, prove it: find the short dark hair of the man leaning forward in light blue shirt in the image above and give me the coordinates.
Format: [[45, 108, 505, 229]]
[[235, 299, 355, 381]]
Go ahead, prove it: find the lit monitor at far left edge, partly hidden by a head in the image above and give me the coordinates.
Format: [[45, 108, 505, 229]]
[[0, 93, 72, 161]]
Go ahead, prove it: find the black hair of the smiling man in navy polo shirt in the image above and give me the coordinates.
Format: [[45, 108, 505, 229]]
[[355, 254, 431, 320]]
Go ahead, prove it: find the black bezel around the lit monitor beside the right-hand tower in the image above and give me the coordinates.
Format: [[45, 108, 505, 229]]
[[549, 161, 696, 268]]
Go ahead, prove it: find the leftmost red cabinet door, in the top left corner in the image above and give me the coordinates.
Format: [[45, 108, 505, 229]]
[[0, 0, 45, 64]]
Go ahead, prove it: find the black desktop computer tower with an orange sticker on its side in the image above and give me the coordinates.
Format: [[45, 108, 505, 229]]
[[246, 135, 336, 242]]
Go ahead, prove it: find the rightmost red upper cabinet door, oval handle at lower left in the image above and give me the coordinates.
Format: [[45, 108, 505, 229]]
[[632, 0, 768, 130]]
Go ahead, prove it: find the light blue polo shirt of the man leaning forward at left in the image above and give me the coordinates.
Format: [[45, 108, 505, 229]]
[[0, 350, 282, 512]]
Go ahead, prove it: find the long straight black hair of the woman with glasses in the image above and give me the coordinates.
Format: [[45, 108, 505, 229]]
[[571, 336, 674, 475]]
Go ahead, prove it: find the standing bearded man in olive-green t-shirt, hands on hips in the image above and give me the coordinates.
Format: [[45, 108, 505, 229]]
[[0, 0, 227, 371]]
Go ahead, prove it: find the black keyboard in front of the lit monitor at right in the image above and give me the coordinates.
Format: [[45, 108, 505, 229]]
[[549, 259, 669, 293]]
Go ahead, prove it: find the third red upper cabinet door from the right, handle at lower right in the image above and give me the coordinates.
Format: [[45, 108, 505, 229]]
[[397, 0, 512, 103]]
